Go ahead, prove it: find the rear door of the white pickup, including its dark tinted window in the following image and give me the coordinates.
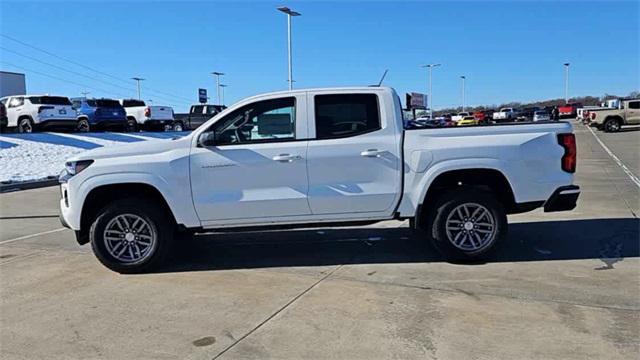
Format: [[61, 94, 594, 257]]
[[307, 89, 402, 218]]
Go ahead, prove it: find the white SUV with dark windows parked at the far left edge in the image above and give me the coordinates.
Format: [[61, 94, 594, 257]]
[[1, 95, 77, 132]]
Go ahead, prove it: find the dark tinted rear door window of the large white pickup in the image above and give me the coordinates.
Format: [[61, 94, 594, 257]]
[[314, 94, 382, 140]]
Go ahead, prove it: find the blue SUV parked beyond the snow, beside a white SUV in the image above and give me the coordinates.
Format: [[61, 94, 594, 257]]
[[71, 98, 127, 132]]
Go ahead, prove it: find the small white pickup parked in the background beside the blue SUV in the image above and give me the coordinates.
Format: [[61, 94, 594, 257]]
[[118, 99, 173, 131]]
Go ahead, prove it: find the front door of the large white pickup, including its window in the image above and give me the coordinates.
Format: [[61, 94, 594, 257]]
[[190, 95, 310, 226]]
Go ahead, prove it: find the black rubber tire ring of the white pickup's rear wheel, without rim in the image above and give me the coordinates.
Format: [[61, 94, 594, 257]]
[[429, 189, 508, 261]]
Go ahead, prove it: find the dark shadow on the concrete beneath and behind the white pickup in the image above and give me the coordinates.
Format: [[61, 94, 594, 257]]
[[158, 218, 640, 272]]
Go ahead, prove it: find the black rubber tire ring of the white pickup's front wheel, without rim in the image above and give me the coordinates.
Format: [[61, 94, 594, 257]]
[[89, 199, 173, 274]]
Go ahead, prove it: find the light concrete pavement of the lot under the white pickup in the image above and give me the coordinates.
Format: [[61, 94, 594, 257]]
[[0, 121, 640, 359]]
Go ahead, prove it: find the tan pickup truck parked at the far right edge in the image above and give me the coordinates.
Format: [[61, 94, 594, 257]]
[[586, 98, 640, 132]]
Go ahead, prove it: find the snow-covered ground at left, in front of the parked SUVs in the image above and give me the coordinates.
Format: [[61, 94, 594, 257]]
[[0, 132, 188, 183]]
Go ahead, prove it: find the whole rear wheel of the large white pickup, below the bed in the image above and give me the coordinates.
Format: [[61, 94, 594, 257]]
[[423, 188, 507, 261]]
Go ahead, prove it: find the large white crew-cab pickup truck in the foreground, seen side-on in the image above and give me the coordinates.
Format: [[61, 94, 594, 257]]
[[60, 87, 580, 273]]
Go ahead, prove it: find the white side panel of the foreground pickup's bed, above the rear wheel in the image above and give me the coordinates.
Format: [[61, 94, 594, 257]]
[[399, 121, 572, 215]]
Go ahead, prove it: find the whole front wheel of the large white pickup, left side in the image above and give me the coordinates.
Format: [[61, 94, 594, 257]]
[[89, 198, 175, 274]]
